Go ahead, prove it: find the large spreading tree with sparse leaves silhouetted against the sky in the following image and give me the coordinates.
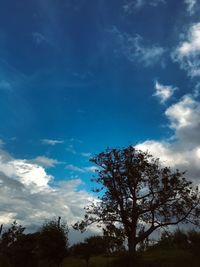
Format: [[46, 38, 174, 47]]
[[74, 146, 200, 253]]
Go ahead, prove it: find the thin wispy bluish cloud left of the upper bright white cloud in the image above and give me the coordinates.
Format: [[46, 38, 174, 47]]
[[110, 26, 165, 67]]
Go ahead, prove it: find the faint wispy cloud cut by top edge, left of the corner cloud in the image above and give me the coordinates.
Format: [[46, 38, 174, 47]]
[[123, 0, 166, 14]]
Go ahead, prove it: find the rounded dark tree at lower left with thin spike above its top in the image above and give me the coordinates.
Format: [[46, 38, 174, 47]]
[[38, 217, 68, 267]]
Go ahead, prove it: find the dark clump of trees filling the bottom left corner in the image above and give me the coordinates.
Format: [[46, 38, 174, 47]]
[[0, 218, 69, 267]]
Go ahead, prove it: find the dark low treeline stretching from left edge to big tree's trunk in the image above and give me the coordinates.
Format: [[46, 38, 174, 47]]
[[0, 217, 125, 267]]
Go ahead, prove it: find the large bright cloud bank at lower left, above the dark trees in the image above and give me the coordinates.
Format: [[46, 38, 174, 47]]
[[0, 150, 95, 243]]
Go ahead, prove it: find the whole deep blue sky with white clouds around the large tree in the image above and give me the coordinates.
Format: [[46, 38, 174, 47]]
[[0, 0, 200, 243]]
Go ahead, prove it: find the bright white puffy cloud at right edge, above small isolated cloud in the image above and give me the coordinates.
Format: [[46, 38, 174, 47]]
[[172, 23, 200, 77]]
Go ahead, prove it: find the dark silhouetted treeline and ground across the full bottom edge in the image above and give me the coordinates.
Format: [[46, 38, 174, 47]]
[[0, 220, 200, 267]]
